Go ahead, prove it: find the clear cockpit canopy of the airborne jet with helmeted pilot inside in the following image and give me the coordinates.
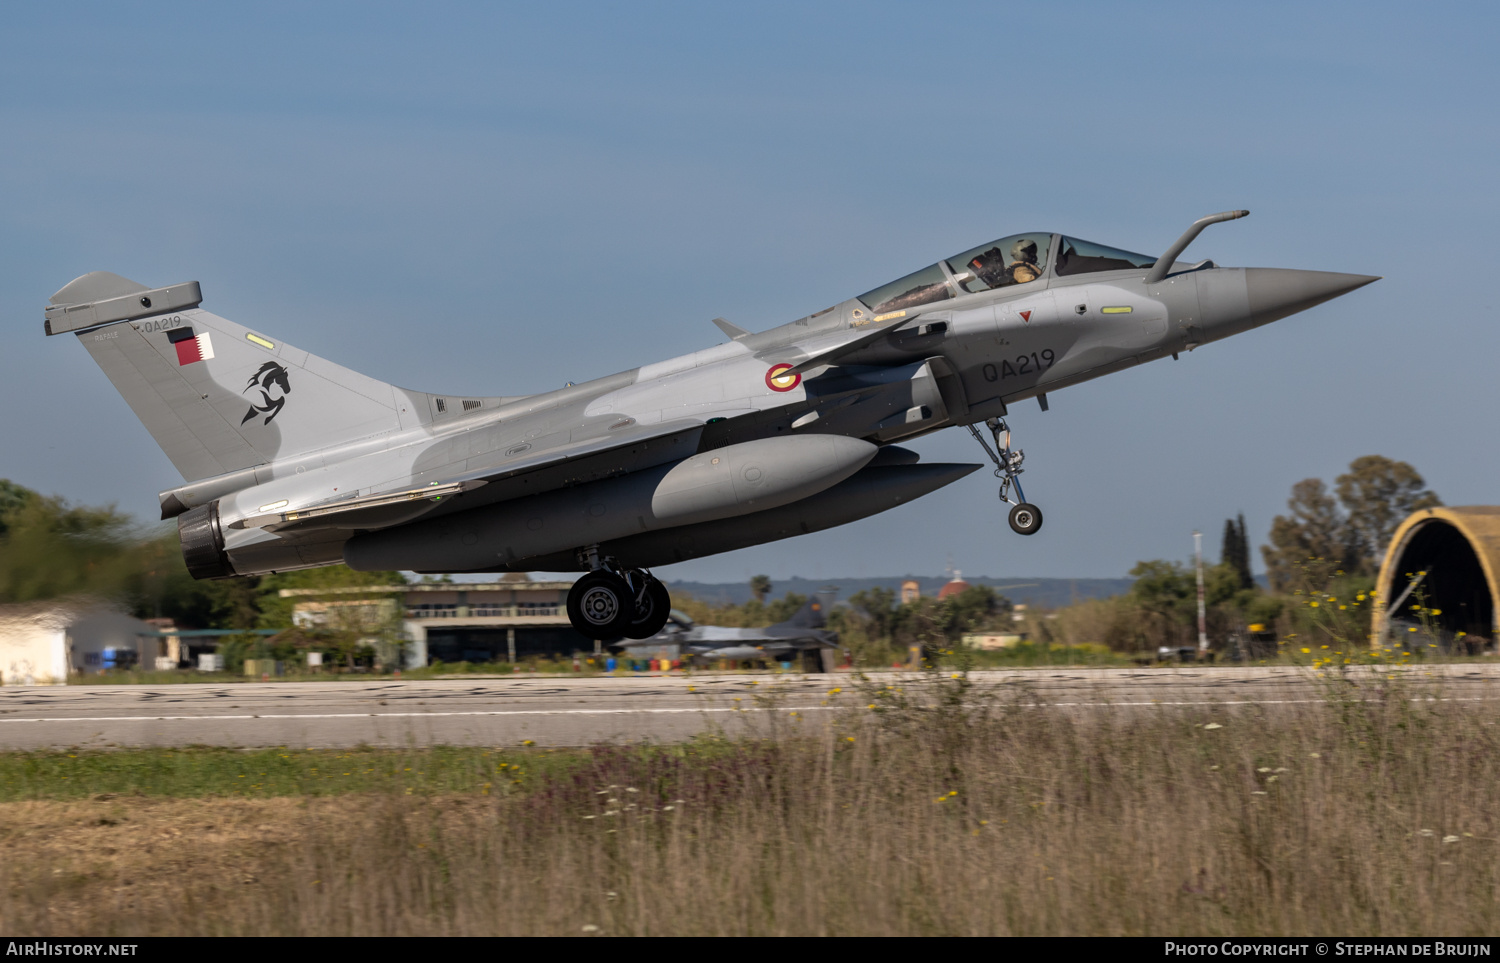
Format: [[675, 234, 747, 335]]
[[860, 234, 1155, 318]]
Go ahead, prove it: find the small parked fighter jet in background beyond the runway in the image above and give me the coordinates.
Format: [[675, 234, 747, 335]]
[[621, 593, 839, 672]]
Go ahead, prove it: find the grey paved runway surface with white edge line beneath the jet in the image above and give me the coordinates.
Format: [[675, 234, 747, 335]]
[[0, 663, 1500, 749]]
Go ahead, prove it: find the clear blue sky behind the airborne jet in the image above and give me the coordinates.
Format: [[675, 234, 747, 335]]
[[0, 3, 1500, 581]]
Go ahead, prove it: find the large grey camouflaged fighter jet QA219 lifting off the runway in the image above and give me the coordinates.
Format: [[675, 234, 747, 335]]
[[45, 210, 1377, 641]]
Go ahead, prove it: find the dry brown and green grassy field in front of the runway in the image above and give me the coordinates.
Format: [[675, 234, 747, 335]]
[[0, 666, 1500, 936]]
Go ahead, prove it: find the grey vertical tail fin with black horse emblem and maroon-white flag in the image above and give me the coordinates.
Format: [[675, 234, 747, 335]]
[[47, 272, 425, 480]]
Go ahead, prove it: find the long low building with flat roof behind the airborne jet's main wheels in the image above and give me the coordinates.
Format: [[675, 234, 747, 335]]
[[281, 573, 596, 668]]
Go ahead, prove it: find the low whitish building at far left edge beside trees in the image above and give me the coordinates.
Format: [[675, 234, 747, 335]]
[[0, 600, 162, 686]]
